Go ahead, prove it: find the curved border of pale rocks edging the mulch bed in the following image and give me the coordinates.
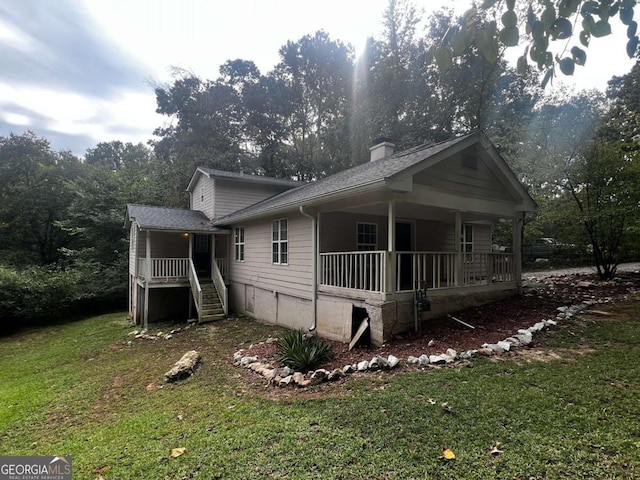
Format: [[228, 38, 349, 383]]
[[233, 303, 588, 387]]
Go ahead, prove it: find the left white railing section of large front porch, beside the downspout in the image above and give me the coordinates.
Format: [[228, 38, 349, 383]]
[[320, 251, 387, 292]]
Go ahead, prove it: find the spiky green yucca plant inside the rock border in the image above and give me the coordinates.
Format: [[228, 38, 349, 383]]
[[277, 330, 333, 372]]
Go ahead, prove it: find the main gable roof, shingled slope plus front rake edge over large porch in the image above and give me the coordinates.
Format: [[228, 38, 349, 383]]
[[213, 132, 536, 225]]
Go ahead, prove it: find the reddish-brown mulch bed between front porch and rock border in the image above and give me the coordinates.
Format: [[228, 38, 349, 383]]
[[249, 272, 640, 370]]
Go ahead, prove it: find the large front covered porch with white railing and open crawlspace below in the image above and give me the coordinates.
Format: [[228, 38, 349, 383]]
[[308, 193, 523, 344]]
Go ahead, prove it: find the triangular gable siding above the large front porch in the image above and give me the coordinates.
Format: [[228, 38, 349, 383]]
[[414, 156, 512, 200]]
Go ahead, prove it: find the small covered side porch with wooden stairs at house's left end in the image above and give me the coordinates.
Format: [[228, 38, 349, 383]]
[[127, 205, 229, 329]]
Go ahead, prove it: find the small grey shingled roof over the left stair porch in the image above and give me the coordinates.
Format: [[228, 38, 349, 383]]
[[125, 204, 221, 233]]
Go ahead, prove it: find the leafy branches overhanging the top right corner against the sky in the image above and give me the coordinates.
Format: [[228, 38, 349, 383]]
[[436, 0, 638, 87]]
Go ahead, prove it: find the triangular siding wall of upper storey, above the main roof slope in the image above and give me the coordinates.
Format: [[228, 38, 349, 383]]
[[215, 178, 290, 218]]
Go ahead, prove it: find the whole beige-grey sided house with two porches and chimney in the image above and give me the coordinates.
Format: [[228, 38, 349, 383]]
[[126, 132, 536, 344]]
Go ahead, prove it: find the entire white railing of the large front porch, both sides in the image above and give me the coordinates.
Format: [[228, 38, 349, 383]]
[[320, 251, 514, 292]]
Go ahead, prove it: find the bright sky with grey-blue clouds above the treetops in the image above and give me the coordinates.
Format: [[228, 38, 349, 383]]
[[0, 0, 634, 156]]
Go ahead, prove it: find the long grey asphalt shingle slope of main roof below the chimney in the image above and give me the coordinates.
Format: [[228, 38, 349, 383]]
[[213, 134, 474, 225]]
